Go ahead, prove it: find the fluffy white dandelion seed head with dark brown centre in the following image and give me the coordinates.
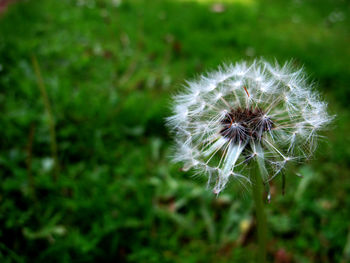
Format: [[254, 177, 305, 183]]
[[167, 60, 332, 196]]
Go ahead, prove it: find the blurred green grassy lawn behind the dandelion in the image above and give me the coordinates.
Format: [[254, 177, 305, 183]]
[[0, 0, 350, 263]]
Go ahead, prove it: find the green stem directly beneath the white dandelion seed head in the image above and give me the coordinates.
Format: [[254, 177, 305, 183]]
[[253, 162, 267, 263]]
